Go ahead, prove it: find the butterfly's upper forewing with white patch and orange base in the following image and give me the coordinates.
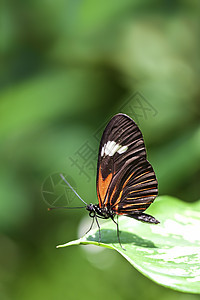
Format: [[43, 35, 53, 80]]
[[97, 114, 146, 208]]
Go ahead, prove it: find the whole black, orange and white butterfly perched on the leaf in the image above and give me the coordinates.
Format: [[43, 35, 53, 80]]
[[58, 113, 160, 247]]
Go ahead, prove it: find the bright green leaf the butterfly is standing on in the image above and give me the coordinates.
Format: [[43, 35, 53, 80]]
[[57, 196, 200, 293]]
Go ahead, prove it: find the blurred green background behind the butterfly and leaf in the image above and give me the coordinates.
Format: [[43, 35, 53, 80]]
[[0, 0, 200, 300]]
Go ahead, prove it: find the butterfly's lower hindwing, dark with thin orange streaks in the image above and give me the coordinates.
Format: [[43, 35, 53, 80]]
[[110, 159, 158, 216]]
